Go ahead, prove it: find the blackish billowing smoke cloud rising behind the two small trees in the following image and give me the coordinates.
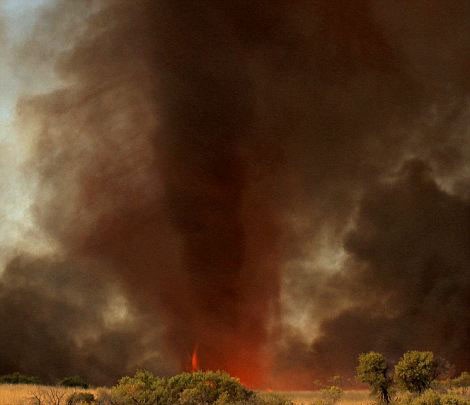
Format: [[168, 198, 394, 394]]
[[280, 161, 470, 386]]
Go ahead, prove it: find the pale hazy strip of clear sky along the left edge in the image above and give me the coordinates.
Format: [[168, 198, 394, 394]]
[[0, 0, 57, 263]]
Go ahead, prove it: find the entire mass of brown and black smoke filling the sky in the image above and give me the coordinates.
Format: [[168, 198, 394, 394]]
[[0, 0, 470, 388]]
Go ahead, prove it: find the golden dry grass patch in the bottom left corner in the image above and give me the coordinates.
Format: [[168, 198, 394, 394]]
[[0, 384, 94, 405]]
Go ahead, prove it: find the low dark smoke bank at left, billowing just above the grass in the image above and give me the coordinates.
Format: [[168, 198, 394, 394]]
[[0, 256, 171, 384]]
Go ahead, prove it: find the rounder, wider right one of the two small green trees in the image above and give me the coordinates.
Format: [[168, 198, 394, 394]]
[[395, 351, 438, 394]]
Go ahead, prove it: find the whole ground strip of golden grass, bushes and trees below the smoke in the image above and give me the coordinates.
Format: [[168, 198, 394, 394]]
[[0, 351, 470, 405]]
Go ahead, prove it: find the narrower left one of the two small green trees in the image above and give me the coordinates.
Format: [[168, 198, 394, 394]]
[[356, 352, 392, 404]]
